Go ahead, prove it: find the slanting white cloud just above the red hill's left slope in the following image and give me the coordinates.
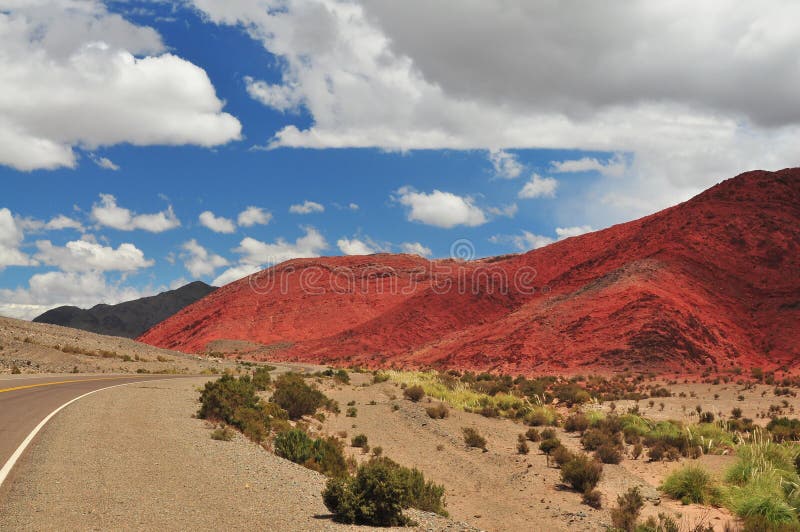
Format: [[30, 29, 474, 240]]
[[213, 226, 328, 286]]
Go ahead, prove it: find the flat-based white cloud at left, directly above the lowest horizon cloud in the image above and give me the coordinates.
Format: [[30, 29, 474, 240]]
[[35, 239, 154, 272]]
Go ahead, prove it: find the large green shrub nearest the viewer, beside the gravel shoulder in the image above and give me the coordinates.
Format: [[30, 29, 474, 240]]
[[322, 458, 445, 526]]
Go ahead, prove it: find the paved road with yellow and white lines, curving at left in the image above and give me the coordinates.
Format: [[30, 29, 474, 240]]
[[0, 375, 188, 498]]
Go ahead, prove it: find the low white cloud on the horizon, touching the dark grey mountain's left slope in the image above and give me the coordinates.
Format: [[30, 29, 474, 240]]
[[0, 271, 149, 319]]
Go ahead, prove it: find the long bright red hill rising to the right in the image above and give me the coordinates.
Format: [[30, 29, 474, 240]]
[[139, 169, 800, 373]]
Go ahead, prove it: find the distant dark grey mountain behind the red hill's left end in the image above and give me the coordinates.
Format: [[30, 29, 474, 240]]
[[33, 281, 216, 338]]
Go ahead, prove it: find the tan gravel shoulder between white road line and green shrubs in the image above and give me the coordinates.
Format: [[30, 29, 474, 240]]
[[0, 378, 471, 531]]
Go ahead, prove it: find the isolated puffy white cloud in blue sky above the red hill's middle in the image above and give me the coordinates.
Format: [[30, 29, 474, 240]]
[[397, 187, 487, 229]]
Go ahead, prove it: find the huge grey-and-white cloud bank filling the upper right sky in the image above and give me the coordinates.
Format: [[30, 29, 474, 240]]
[[194, 0, 800, 224]]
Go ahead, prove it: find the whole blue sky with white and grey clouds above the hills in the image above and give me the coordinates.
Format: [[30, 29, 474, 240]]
[[0, 0, 798, 318]]
